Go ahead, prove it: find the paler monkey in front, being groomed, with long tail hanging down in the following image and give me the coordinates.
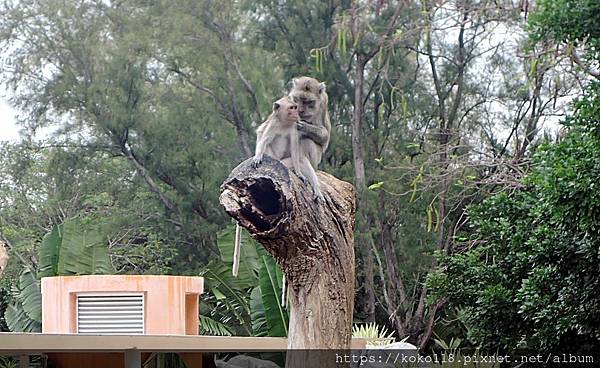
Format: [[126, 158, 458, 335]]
[[233, 96, 324, 276]]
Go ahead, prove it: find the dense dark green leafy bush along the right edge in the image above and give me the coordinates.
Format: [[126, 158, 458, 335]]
[[429, 98, 600, 353]]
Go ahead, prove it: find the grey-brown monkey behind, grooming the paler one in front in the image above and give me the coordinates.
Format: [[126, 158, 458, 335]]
[[289, 77, 331, 170]]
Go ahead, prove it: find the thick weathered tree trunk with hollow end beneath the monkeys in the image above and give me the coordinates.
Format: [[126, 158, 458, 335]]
[[220, 157, 355, 367]]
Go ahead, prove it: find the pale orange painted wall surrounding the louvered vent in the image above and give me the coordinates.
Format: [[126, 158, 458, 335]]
[[42, 275, 204, 335]]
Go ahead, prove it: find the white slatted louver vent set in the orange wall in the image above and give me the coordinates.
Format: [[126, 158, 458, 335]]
[[77, 294, 144, 335]]
